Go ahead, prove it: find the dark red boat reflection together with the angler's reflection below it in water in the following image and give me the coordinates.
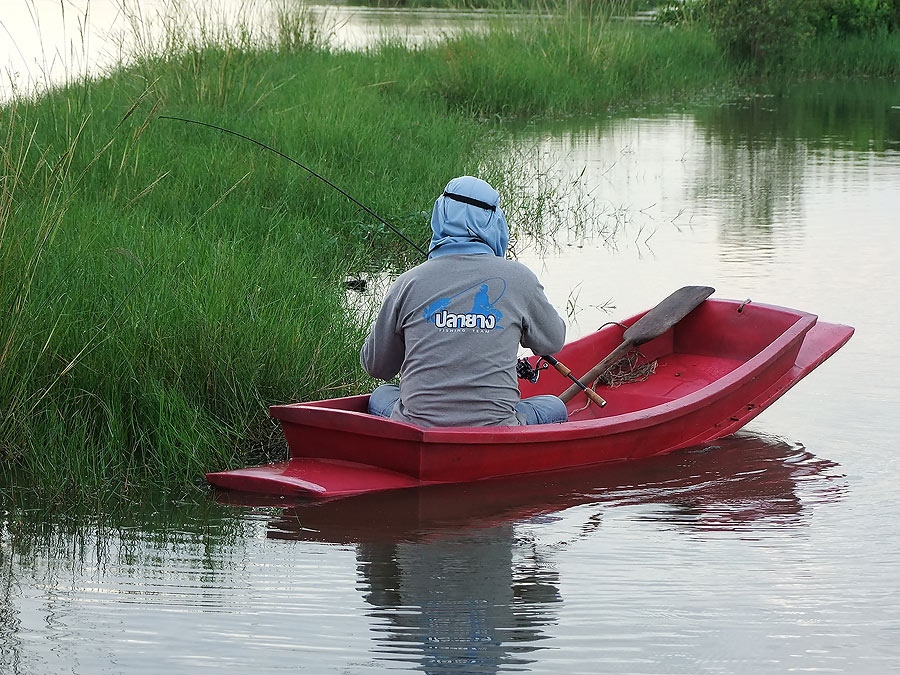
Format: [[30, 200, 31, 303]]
[[220, 433, 844, 672]]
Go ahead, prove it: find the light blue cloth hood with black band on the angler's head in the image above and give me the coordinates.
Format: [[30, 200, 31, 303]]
[[428, 176, 509, 258]]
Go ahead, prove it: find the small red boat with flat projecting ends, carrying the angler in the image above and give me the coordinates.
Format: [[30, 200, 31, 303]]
[[207, 298, 853, 499]]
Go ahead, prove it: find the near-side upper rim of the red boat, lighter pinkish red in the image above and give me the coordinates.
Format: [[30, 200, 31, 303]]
[[269, 298, 818, 445]]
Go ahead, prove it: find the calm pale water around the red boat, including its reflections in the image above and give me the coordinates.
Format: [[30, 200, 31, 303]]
[[0, 29, 900, 674]]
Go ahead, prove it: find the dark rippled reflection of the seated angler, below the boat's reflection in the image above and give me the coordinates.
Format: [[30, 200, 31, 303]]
[[357, 524, 561, 673]]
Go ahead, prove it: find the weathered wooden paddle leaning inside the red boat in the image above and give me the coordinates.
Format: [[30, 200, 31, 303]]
[[559, 286, 716, 407]]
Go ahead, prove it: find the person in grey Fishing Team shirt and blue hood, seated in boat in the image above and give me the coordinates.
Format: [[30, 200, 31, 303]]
[[360, 176, 567, 427]]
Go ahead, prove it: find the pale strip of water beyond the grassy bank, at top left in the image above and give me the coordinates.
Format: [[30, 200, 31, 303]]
[[0, 0, 500, 101]]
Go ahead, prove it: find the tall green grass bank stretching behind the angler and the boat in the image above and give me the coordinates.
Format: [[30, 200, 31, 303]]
[[0, 0, 900, 503]]
